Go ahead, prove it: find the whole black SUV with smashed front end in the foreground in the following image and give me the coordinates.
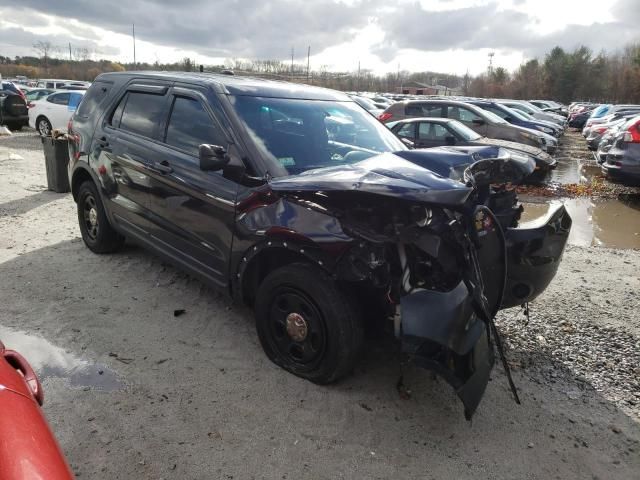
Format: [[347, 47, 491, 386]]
[[69, 72, 571, 417]]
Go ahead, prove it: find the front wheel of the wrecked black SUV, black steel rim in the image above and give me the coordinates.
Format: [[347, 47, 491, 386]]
[[255, 263, 364, 384]]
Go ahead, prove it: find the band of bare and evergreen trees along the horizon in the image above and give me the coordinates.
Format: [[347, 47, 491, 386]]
[[0, 42, 640, 103]]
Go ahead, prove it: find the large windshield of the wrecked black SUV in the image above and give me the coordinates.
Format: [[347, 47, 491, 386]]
[[231, 96, 407, 175]]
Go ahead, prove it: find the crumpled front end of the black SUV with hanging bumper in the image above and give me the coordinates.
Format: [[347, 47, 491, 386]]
[[239, 159, 571, 419]]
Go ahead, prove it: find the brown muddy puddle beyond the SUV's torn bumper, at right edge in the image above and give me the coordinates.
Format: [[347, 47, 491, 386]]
[[522, 194, 640, 248]]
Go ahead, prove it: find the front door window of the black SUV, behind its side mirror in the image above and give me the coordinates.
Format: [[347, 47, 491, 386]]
[[165, 97, 226, 155]]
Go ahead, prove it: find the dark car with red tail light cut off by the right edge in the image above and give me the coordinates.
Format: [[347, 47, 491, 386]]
[[602, 116, 640, 185]]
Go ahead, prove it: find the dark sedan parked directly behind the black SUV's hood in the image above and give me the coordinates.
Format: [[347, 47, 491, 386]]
[[387, 118, 557, 183]]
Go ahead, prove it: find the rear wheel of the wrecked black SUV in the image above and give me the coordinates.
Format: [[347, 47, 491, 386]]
[[78, 181, 124, 253]]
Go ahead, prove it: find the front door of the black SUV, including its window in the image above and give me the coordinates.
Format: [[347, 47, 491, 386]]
[[142, 85, 239, 286]]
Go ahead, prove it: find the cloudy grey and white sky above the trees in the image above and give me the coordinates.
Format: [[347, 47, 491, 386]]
[[0, 0, 640, 74]]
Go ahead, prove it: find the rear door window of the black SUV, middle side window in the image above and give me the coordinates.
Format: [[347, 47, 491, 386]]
[[117, 92, 165, 137]]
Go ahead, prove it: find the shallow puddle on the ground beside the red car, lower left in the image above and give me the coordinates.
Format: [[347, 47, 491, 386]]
[[0, 326, 125, 391]]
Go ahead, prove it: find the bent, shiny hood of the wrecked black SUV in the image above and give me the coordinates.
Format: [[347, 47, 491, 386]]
[[269, 151, 472, 206]]
